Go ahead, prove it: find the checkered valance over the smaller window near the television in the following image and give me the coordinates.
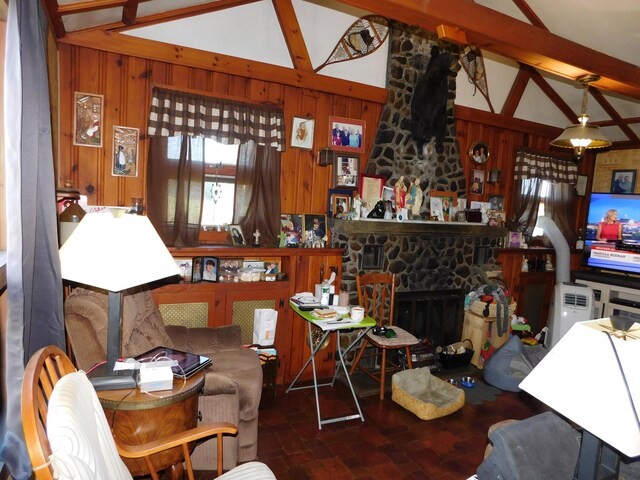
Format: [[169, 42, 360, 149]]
[[513, 149, 578, 185]]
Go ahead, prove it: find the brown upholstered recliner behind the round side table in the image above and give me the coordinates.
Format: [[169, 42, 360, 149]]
[[64, 288, 262, 470]]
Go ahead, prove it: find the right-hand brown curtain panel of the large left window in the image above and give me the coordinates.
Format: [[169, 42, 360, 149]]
[[233, 141, 280, 245]]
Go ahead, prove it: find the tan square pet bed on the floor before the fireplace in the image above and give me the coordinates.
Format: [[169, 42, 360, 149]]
[[391, 367, 465, 420]]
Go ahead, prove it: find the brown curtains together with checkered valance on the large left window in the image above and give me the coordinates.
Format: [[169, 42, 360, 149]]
[[147, 87, 286, 245]]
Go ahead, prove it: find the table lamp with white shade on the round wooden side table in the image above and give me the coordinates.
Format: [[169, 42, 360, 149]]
[[60, 208, 179, 390]]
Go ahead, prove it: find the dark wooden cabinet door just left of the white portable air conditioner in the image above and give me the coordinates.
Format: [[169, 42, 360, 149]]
[[516, 272, 556, 334]]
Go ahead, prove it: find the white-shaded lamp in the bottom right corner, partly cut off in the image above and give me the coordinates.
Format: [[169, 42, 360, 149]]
[[520, 317, 640, 480]]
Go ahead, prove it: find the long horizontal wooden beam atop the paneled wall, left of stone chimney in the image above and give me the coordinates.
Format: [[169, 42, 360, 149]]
[[58, 30, 388, 104]]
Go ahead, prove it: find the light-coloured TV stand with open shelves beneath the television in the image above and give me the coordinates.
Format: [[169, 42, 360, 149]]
[[574, 270, 640, 321]]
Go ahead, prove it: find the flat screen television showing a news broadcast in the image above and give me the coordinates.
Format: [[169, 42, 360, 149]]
[[585, 193, 640, 273]]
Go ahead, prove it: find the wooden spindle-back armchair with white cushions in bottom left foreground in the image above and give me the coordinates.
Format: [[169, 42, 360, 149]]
[[22, 346, 275, 480]]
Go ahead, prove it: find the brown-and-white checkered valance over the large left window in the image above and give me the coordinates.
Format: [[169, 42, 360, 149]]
[[147, 87, 286, 151]]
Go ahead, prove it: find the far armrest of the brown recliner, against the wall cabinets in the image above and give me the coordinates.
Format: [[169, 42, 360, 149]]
[[166, 325, 242, 355]]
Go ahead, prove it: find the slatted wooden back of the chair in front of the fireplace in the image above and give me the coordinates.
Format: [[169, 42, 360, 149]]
[[356, 273, 396, 326]]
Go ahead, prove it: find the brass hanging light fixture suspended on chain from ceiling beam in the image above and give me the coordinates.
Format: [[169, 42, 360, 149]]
[[551, 75, 611, 158]]
